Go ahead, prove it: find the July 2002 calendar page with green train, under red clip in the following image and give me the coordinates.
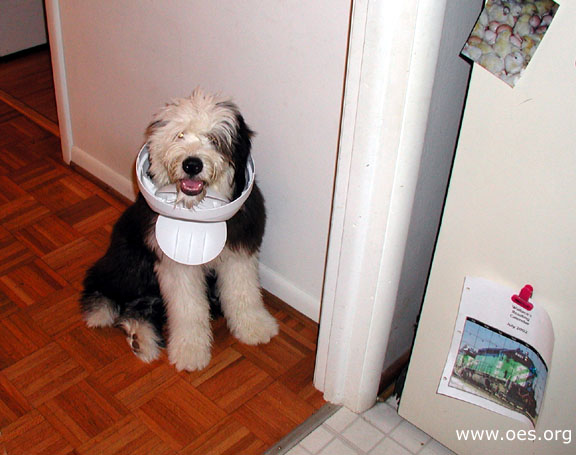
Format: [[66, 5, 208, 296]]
[[438, 277, 554, 427]]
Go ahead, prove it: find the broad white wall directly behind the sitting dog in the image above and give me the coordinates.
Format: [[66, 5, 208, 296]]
[[49, 0, 350, 319]]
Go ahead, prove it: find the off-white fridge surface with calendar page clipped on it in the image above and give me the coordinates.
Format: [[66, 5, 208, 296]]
[[399, 0, 576, 455]]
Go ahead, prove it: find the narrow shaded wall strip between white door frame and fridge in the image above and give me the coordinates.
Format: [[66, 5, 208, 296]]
[[384, 0, 483, 369]]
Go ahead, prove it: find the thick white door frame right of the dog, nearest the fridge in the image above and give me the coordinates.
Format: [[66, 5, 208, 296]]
[[314, 0, 446, 412]]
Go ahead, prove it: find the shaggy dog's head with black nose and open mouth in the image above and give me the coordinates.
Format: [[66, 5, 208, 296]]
[[147, 90, 253, 207]]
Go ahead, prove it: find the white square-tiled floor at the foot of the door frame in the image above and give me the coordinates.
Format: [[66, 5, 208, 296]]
[[287, 397, 454, 455]]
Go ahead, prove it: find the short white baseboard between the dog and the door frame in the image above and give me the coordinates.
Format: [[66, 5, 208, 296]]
[[260, 263, 320, 322]]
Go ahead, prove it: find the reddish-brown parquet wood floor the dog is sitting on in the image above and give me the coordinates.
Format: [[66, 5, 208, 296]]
[[0, 63, 324, 455]]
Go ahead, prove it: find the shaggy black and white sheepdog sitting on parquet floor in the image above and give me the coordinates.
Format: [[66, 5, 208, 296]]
[[81, 90, 278, 371]]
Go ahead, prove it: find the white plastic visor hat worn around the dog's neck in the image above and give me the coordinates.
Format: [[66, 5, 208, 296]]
[[136, 144, 255, 265]]
